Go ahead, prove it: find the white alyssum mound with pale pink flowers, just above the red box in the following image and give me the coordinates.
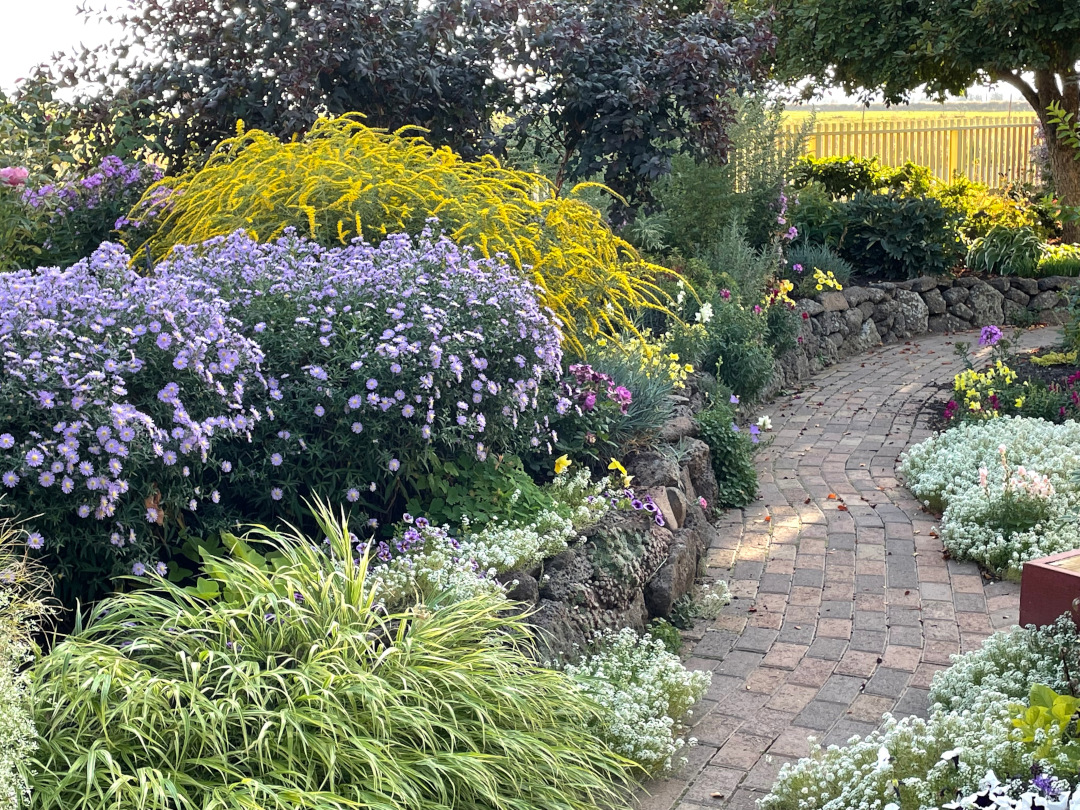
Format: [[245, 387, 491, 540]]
[[900, 417, 1080, 573]]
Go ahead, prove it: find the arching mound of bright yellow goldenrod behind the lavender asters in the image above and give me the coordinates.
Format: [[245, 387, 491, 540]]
[[129, 116, 667, 348]]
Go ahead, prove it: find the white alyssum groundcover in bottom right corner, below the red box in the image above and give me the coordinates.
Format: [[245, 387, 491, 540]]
[[760, 622, 1080, 810]]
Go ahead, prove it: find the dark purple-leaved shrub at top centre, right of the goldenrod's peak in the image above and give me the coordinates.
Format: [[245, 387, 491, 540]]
[[511, 0, 771, 213]]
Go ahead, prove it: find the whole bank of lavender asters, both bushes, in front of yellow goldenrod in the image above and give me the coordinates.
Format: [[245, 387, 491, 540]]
[[0, 232, 562, 596]]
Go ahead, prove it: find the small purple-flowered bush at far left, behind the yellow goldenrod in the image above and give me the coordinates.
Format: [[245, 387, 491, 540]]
[[23, 156, 163, 267]]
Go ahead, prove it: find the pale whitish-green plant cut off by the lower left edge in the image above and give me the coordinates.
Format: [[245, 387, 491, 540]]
[[0, 588, 36, 810]]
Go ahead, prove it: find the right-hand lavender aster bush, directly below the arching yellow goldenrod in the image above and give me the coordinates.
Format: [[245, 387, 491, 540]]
[[169, 230, 562, 511]]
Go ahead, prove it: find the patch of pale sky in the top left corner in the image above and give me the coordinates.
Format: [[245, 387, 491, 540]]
[[0, 0, 119, 91]]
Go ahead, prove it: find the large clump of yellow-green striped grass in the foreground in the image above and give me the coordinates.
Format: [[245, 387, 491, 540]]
[[21, 507, 627, 810]]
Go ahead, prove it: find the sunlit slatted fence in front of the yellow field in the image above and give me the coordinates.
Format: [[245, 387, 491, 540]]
[[784, 116, 1036, 188]]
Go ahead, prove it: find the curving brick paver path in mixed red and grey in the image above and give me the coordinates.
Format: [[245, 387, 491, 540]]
[[639, 329, 1057, 810]]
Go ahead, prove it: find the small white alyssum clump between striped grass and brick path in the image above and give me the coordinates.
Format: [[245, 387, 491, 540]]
[[564, 629, 713, 774]]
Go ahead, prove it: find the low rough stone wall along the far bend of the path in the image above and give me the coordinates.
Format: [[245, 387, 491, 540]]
[[766, 275, 1077, 395]]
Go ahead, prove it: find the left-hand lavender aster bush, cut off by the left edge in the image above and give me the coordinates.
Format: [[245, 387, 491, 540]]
[[0, 244, 266, 596]]
